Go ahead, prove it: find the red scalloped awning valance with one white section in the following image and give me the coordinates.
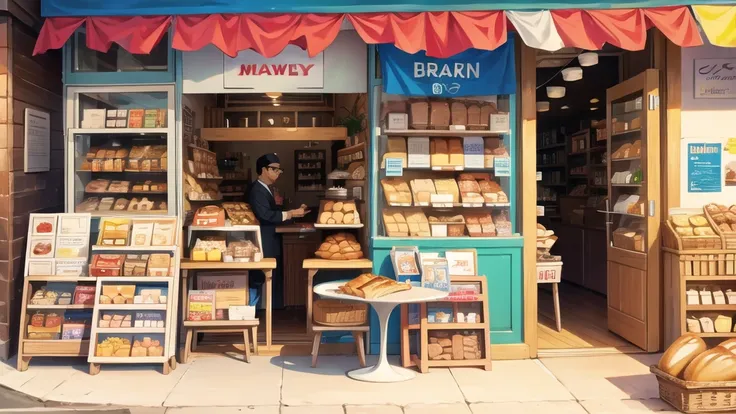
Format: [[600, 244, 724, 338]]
[[34, 6, 703, 57]]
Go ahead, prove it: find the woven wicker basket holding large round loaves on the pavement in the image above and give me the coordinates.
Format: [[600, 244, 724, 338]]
[[650, 365, 736, 413]]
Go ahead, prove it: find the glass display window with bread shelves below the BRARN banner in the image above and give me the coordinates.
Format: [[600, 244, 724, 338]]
[[376, 94, 517, 238]]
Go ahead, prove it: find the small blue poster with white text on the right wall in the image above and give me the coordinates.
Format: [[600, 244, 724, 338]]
[[687, 143, 721, 193]]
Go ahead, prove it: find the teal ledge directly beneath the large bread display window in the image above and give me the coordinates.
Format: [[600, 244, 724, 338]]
[[373, 236, 524, 249]]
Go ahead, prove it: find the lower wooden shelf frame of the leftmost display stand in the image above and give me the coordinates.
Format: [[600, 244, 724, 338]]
[[17, 276, 97, 371]]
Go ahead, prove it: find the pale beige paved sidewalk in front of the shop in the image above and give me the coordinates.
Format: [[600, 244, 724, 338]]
[[0, 354, 676, 414]]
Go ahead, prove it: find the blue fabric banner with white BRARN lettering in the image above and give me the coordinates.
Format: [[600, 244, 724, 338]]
[[378, 41, 516, 98]]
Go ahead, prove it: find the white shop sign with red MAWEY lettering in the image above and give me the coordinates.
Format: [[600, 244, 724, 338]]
[[223, 46, 324, 92]]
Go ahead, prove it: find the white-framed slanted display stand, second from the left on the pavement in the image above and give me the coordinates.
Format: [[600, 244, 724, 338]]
[[88, 216, 181, 375]]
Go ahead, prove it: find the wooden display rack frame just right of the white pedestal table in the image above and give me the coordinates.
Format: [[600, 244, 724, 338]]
[[401, 276, 491, 373]]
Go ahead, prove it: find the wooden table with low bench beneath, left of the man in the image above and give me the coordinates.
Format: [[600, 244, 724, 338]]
[[180, 257, 276, 363]]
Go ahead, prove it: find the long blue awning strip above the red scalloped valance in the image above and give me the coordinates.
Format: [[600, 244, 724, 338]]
[[41, 0, 732, 17]]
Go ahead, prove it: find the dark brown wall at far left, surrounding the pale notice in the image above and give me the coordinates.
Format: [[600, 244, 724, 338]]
[[0, 2, 64, 359]]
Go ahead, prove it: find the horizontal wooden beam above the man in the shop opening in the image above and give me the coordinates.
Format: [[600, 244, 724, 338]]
[[201, 127, 348, 142]]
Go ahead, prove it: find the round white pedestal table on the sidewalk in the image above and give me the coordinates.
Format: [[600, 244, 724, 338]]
[[314, 281, 447, 382]]
